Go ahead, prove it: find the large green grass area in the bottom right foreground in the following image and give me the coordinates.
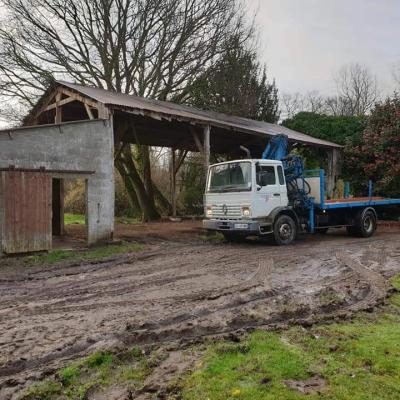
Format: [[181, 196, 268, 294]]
[[181, 275, 400, 400]]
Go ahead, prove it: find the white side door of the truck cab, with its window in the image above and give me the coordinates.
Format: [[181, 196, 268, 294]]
[[255, 163, 281, 217]]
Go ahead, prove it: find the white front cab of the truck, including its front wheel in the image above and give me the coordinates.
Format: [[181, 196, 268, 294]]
[[203, 159, 297, 244]]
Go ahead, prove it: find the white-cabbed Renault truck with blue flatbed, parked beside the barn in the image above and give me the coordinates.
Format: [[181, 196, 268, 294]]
[[203, 157, 400, 245]]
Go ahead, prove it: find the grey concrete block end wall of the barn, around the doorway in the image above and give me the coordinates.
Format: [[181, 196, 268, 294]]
[[0, 120, 115, 247]]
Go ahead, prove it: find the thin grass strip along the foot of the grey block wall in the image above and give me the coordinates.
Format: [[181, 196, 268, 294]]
[[23, 242, 143, 266]]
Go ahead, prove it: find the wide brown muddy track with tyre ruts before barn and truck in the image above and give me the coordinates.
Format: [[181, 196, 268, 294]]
[[0, 223, 400, 399]]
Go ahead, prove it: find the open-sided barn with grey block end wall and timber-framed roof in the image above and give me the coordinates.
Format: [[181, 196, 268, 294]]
[[0, 81, 341, 254]]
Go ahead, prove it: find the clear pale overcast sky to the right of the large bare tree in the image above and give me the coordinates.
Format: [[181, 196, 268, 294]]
[[247, 0, 400, 94]]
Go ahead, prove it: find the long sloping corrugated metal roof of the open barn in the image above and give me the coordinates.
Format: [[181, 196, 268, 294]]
[[57, 81, 342, 148]]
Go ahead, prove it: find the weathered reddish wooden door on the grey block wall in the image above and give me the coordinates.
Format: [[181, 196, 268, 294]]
[[0, 171, 52, 254]]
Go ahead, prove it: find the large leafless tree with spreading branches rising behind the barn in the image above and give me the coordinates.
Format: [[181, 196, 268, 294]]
[[0, 0, 252, 219]]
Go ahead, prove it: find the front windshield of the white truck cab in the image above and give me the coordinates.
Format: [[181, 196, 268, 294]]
[[207, 162, 251, 192]]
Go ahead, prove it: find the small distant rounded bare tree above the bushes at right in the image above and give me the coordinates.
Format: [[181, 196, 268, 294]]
[[335, 63, 378, 115]]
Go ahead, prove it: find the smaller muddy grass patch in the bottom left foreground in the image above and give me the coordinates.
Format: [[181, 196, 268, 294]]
[[22, 347, 152, 400]]
